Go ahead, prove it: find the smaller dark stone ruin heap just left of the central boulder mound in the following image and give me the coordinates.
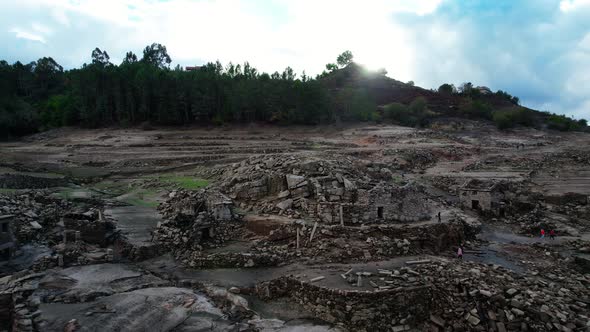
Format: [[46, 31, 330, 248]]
[[153, 189, 242, 252]]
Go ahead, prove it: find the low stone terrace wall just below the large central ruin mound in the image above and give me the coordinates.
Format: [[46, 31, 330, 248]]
[[253, 222, 465, 262]]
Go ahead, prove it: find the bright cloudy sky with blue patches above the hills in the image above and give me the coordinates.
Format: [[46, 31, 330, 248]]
[[0, 0, 590, 119]]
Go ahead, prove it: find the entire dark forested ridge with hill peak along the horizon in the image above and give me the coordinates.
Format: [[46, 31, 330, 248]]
[[0, 43, 586, 137]]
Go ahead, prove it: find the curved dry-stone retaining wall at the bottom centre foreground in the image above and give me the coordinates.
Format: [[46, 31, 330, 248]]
[[256, 277, 433, 331]]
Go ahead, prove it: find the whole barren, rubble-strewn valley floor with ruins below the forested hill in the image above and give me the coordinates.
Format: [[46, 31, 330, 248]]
[[0, 120, 590, 331]]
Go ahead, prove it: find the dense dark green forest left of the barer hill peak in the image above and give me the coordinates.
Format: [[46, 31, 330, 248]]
[[0, 43, 342, 135]]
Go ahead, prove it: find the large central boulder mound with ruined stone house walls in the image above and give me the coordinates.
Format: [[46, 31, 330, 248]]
[[220, 155, 430, 224]]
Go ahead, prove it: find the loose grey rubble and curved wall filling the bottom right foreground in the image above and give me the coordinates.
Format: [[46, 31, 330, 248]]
[[257, 259, 590, 331]]
